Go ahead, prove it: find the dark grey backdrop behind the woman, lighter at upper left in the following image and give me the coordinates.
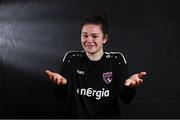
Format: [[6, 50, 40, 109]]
[[0, 0, 180, 118]]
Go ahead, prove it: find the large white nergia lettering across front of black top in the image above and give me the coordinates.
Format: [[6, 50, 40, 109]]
[[77, 88, 109, 100]]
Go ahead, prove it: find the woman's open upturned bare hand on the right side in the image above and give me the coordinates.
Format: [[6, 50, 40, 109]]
[[125, 72, 146, 87]]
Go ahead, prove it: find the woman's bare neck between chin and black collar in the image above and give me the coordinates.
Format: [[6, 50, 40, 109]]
[[86, 49, 104, 61]]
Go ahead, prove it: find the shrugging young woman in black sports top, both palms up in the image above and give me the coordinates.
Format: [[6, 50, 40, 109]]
[[46, 12, 146, 118]]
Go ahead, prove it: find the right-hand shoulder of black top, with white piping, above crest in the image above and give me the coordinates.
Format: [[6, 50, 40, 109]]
[[105, 52, 127, 64]]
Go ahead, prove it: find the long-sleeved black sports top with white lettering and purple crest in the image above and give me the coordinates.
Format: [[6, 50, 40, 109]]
[[55, 51, 135, 118]]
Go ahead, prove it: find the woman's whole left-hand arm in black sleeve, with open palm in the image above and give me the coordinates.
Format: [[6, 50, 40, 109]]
[[45, 53, 73, 102]]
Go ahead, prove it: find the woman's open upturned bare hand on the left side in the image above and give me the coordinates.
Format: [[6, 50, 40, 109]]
[[45, 70, 67, 85]]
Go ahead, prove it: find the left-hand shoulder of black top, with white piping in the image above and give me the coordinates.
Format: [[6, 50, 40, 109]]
[[63, 51, 84, 62]]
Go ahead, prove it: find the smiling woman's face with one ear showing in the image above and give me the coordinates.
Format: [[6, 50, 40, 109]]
[[81, 24, 107, 54]]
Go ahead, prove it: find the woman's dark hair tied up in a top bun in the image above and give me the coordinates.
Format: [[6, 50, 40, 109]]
[[82, 10, 108, 35]]
